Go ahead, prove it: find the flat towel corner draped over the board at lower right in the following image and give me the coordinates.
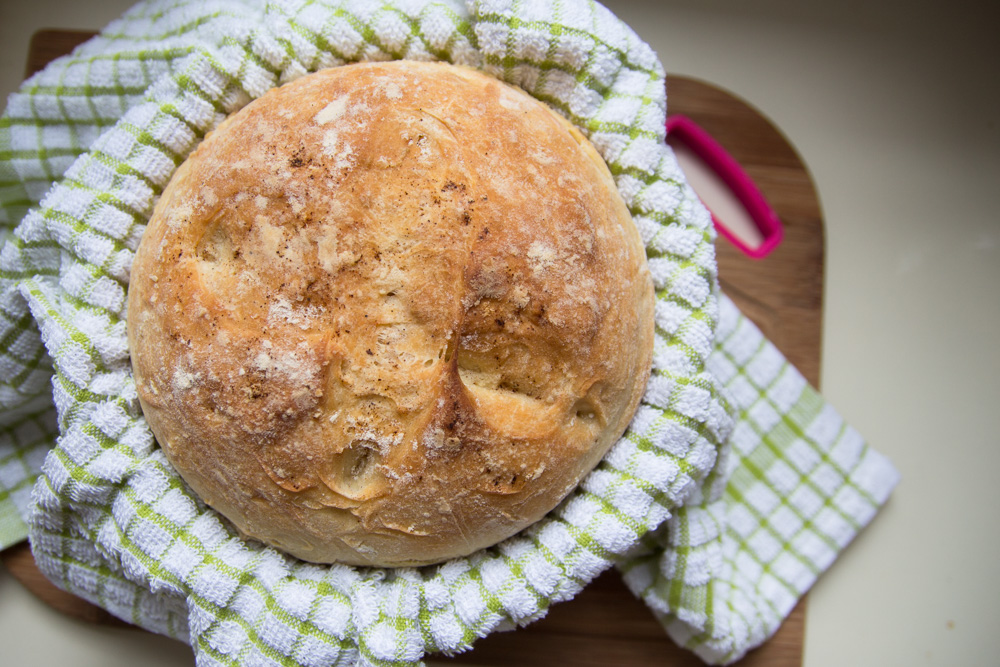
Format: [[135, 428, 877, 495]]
[[618, 296, 898, 664]]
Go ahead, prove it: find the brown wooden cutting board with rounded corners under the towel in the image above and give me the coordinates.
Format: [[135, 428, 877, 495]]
[[0, 30, 824, 667]]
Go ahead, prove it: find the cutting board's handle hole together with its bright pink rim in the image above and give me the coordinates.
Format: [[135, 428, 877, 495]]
[[667, 115, 783, 259]]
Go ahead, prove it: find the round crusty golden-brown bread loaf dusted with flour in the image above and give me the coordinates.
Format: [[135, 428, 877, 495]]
[[128, 61, 653, 566]]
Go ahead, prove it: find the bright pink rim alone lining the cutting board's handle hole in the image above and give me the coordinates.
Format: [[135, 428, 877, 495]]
[[667, 115, 784, 259]]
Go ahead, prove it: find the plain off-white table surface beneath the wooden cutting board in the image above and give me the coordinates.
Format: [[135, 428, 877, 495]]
[[0, 0, 1000, 667]]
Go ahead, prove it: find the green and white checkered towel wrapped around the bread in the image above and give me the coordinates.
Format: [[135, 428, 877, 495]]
[[0, 0, 897, 665]]
